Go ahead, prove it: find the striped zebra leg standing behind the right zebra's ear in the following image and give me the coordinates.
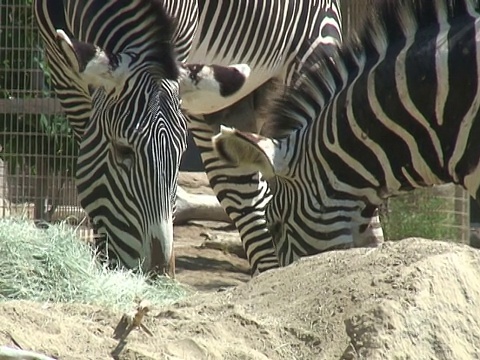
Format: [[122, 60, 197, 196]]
[[189, 95, 278, 275]]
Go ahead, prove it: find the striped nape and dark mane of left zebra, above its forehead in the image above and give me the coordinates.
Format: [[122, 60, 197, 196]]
[[61, 0, 179, 79]]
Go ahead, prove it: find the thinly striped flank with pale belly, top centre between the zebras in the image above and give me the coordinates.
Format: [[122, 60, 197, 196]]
[[189, 0, 341, 90]]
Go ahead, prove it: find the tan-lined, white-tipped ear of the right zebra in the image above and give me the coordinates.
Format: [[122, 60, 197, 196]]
[[212, 125, 277, 181]]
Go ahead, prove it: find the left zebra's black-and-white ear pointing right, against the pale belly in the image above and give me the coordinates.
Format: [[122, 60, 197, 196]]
[[180, 64, 250, 113]]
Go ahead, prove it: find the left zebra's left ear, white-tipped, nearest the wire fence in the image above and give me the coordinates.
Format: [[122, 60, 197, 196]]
[[57, 30, 128, 87]]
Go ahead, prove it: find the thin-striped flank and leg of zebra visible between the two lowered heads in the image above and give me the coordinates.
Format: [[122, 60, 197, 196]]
[[182, 0, 383, 275]]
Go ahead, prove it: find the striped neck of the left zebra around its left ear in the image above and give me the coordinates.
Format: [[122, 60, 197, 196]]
[[34, 0, 198, 140]]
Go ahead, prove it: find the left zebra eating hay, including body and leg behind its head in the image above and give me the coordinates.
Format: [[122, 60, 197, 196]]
[[35, 0, 381, 272]]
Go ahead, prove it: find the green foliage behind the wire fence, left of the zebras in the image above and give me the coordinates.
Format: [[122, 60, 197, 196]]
[[0, 0, 77, 175]]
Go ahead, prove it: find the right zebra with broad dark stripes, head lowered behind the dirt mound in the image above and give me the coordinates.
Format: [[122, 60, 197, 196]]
[[212, 0, 480, 265]]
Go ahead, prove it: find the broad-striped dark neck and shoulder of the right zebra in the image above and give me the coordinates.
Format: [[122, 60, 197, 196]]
[[292, 0, 480, 204]]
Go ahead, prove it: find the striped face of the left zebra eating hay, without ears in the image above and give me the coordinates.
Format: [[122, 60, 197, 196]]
[[76, 77, 187, 270]]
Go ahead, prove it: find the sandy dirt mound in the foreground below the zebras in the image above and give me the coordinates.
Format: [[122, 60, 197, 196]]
[[0, 239, 480, 360]]
